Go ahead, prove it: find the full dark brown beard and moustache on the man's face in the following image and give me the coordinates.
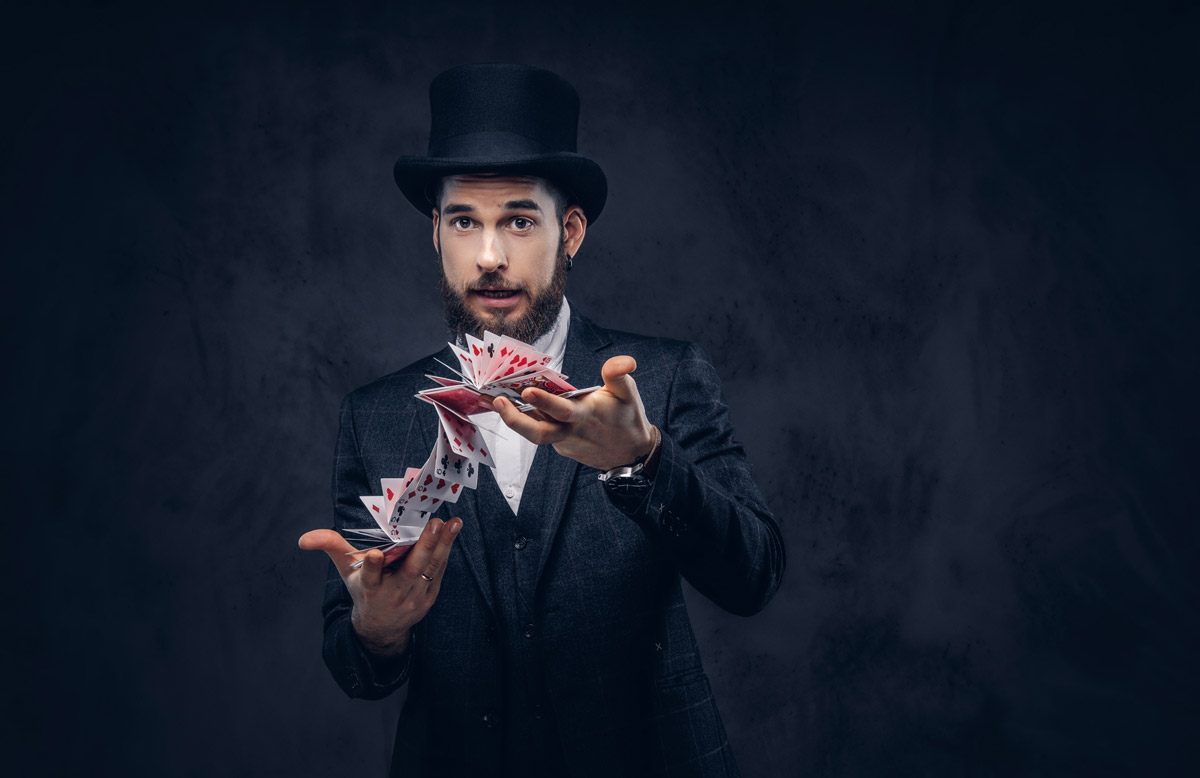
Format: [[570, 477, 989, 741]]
[[438, 243, 566, 343]]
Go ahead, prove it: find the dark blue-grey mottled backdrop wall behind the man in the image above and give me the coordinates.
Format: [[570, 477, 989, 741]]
[[0, 2, 1200, 776]]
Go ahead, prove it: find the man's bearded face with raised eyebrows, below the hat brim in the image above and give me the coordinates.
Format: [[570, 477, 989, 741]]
[[433, 175, 586, 342]]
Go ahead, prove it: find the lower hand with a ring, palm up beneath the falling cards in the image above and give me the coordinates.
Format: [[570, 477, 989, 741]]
[[300, 519, 462, 658]]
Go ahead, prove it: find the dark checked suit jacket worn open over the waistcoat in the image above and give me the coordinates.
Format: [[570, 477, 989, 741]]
[[324, 312, 784, 778]]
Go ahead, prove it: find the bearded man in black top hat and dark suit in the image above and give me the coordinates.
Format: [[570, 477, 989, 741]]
[[300, 65, 784, 777]]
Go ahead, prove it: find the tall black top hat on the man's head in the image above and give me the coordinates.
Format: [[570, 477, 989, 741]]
[[394, 65, 608, 222]]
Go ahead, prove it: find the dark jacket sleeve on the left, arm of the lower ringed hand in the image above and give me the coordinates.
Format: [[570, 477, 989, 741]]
[[322, 395, 415, 700]]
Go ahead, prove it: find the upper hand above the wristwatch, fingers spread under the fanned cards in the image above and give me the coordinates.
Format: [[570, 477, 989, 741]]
[[492, 357, 654, 471]]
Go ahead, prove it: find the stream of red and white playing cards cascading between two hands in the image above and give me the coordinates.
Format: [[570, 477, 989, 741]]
[[342, 331, 599, 567]]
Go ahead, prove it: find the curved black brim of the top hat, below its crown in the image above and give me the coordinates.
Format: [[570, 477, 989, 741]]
[[392, 151, 608, 222]]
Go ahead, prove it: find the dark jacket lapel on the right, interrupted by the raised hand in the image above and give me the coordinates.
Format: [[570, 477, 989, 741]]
[[522, 306, 611, 591]]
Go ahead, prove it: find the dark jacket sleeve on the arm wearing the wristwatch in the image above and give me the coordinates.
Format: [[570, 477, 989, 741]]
[[629, 343, 785, 616]]
